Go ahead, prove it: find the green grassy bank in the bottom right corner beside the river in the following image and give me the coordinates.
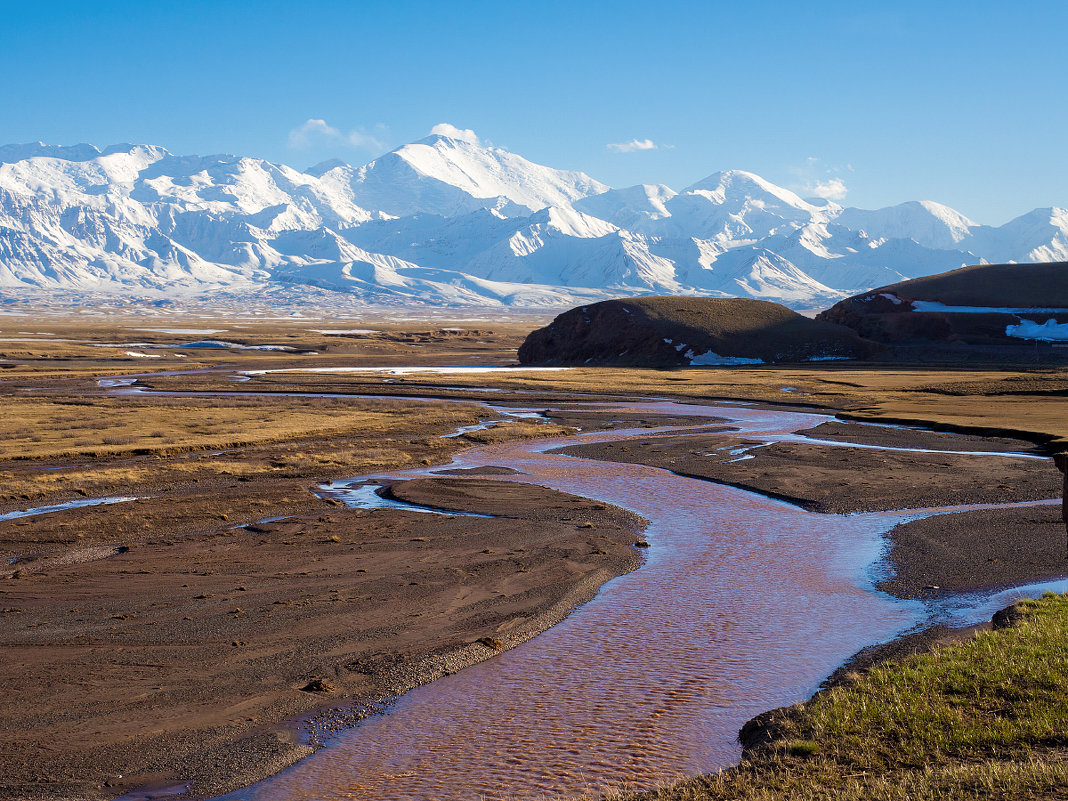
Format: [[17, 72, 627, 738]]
[[615, 593, 1068, 801]]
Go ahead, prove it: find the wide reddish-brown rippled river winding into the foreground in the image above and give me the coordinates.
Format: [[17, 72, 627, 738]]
[[206, 404, 1059, 801]]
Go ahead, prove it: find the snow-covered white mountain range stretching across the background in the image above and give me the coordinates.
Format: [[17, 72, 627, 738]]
[[0, 125, 1068, 309]]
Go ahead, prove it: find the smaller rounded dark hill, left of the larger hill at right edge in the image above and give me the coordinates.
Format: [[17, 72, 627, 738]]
[[519, 297, 878, 367]]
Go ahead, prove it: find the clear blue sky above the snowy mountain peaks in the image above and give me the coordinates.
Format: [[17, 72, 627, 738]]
[[0, 0, 1068, 224]]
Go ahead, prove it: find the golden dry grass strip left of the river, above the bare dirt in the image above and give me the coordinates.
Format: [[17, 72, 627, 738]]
[[0, 397, 574, 514]]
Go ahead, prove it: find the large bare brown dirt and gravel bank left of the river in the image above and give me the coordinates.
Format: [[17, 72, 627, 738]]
[[0, 478, 643, 799]]
